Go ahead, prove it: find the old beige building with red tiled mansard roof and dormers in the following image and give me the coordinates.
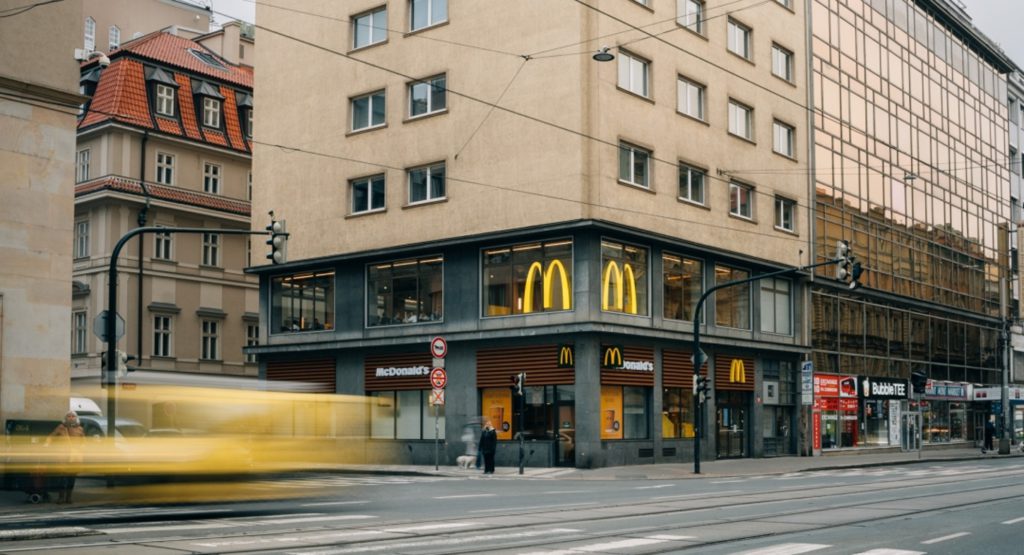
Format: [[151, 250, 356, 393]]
[[71, 32, 259, 391]]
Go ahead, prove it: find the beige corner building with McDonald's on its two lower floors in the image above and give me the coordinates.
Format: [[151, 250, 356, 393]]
[[248, 0, 812, 467]]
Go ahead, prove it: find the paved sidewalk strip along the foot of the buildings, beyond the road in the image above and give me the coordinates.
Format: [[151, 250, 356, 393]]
[[0, 445, 1024, 514]]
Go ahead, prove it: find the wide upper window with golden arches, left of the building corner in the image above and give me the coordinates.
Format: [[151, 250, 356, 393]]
[[482, 240, 573, 316]]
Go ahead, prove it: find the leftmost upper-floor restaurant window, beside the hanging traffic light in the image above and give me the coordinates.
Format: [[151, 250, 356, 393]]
[[270, 270, 334, 333]]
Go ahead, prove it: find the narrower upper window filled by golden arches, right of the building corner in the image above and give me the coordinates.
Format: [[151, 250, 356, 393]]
[[601, 241, 647, 316]]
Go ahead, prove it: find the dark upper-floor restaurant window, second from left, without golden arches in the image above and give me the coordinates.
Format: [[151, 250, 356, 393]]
[[367, 256, 444, 327]]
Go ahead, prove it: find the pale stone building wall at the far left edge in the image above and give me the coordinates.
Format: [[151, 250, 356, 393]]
[[0, 0, 82, 426]]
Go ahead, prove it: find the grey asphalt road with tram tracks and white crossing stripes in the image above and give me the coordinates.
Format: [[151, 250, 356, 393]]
[[0, 459, 1024, 555]]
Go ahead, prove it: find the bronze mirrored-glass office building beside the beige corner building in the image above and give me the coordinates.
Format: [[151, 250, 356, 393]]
[[811, 0, 1013, 447]]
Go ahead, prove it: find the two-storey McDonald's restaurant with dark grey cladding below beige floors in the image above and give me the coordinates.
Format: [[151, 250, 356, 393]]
[[253, 220, 808, 468]]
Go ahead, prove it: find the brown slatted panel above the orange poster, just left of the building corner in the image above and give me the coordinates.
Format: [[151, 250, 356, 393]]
[[476, 345, 575, 387]]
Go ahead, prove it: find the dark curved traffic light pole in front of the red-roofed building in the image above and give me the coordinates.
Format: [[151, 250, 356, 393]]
[[102, 227, 272, 448]]
